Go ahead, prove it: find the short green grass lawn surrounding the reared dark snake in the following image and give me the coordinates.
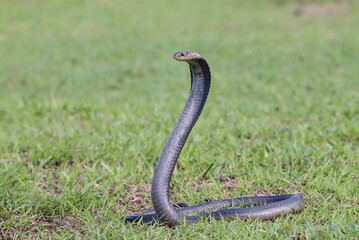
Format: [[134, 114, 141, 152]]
[[0, 0, 359, 239]]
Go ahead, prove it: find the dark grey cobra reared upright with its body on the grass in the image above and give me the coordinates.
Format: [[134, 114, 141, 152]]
[[125, 50, 304, 227]]
